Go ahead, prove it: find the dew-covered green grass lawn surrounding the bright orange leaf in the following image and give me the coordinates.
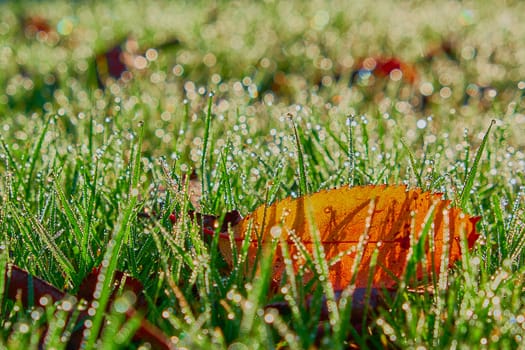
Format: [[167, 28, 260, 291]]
[[0, 0, 525, 350]]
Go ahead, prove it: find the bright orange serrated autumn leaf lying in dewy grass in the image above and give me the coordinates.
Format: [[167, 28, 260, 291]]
[[219, 185, 479, 290]]
